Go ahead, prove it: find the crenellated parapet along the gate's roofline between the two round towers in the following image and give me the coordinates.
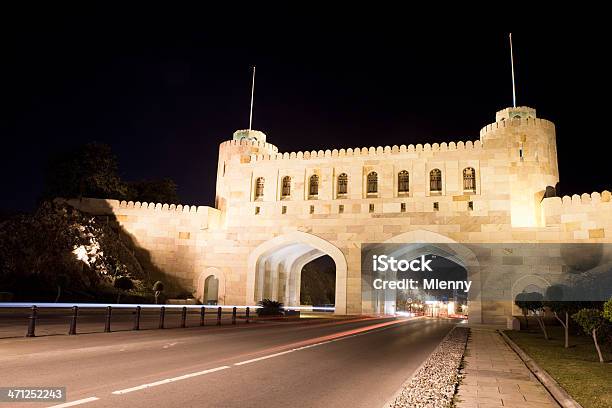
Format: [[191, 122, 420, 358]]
[[244, 140, 483, 162]]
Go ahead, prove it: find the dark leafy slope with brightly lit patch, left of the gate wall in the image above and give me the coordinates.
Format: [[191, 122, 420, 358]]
[[0, 201, 149, 302]]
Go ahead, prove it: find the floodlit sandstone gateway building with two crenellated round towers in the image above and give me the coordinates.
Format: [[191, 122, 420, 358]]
[[70, 107, 612, 322]]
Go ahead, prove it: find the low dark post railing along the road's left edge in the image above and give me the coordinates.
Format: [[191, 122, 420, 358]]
[[0, 302, 335, 337]]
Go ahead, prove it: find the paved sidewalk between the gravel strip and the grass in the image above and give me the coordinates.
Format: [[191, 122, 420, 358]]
[[456, 327, 559, 408]]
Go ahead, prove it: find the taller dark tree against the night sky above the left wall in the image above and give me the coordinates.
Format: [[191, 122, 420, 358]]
[[44, 142, 128, 199]]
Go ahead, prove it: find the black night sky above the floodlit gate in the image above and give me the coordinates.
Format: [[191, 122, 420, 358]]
[[0, 9, 612, 211]]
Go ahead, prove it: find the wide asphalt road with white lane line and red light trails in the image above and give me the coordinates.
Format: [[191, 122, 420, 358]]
[[0, 318, 456, 408]]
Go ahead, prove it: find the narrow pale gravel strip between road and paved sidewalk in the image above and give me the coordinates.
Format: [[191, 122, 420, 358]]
[[389, 327, 470, 408]]
